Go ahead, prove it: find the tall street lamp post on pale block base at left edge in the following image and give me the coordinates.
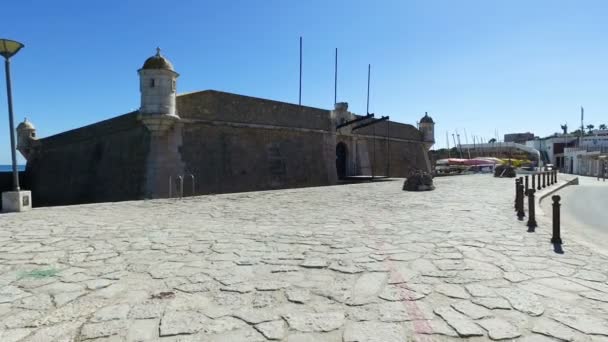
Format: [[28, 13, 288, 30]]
[[0, 39, 31, 211]]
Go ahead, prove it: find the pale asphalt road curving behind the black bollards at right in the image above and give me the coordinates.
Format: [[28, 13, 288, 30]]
[[543, 177, 608, 250]]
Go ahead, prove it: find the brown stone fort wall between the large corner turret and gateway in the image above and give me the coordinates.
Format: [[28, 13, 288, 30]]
[[177, 91, 337, 194]]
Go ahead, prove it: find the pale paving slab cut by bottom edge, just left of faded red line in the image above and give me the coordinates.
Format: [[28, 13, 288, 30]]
[[343, 322, 407, 342]]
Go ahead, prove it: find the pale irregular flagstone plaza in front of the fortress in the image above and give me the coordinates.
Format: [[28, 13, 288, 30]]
[[0, 175, 608, 342]]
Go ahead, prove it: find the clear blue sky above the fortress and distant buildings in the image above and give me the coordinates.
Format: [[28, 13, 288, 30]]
[[0, 0, 608, 164]]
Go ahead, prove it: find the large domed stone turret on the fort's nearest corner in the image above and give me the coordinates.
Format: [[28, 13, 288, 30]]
[[137, 48, 179, 135]]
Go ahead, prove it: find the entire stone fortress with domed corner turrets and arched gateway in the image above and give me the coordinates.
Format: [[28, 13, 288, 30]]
[[17, 49, 434, 206]]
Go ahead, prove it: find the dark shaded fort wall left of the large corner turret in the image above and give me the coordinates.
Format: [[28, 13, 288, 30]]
[[26, 113, 149, 206]]
